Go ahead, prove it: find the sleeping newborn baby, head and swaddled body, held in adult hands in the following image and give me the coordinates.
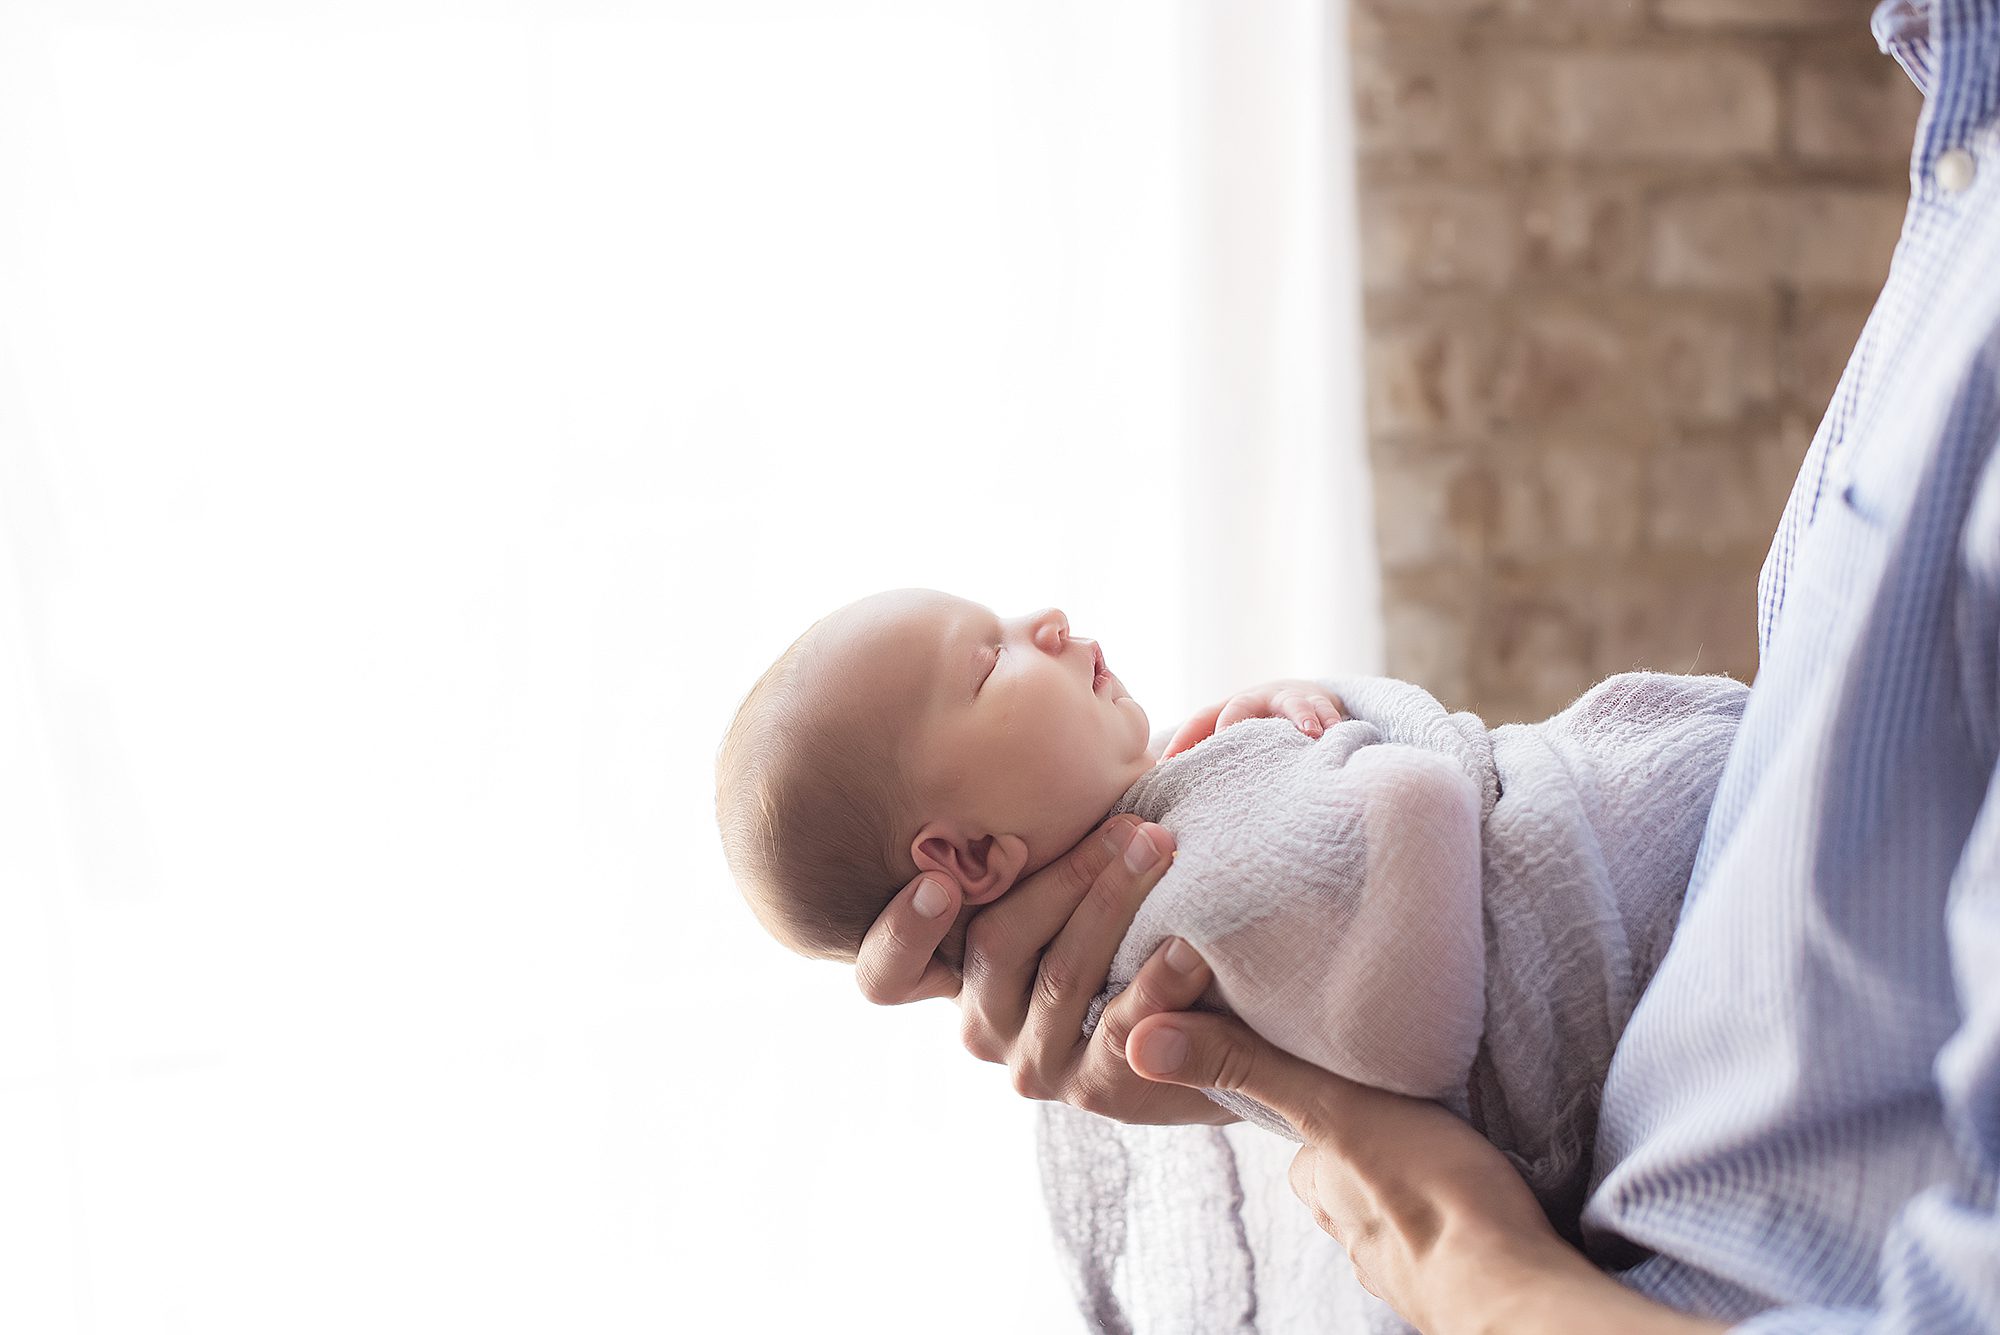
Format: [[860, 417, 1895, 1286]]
[[716, 590, 1746, 1219]]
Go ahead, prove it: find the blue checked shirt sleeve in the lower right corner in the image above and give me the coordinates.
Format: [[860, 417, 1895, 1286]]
[[1736, 751, 2000, 1335]]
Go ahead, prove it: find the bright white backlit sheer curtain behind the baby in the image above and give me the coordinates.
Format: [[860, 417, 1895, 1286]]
[[0, 0, 1380, 1335]]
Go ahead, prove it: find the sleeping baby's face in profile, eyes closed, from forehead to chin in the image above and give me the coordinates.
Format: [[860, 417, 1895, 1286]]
[[816, 590, 1152, 869]]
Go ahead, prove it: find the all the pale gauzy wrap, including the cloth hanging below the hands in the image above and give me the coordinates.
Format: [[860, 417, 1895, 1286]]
[[1040, 673, 1748, 1333]]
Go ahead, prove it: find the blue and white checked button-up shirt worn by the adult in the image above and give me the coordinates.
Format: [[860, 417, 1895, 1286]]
[[1584, 0, 2000, 1335]]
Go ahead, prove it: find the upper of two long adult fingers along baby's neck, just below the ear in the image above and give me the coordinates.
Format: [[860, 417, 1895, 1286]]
[[958, 813, 1140, 1051]]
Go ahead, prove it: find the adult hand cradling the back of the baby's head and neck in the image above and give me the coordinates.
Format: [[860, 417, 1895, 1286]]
[[854, 815, 1234, 1125]]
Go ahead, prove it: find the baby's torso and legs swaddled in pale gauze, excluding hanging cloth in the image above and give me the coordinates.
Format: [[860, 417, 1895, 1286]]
[[1072, 673, 1746, 1227]]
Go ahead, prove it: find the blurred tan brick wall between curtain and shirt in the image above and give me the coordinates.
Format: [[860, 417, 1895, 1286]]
[[1350, 0, 1920, 721]]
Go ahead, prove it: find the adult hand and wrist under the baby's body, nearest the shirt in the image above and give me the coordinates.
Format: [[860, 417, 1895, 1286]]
[[1126, 991, 1726, 1335]]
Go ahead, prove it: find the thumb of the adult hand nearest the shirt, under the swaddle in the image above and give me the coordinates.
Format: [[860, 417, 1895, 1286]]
[[1126, 1011, 1356, 1143]]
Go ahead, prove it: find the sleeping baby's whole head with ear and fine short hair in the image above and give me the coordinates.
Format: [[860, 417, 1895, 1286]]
[[716, 590, 1152, 959]]
